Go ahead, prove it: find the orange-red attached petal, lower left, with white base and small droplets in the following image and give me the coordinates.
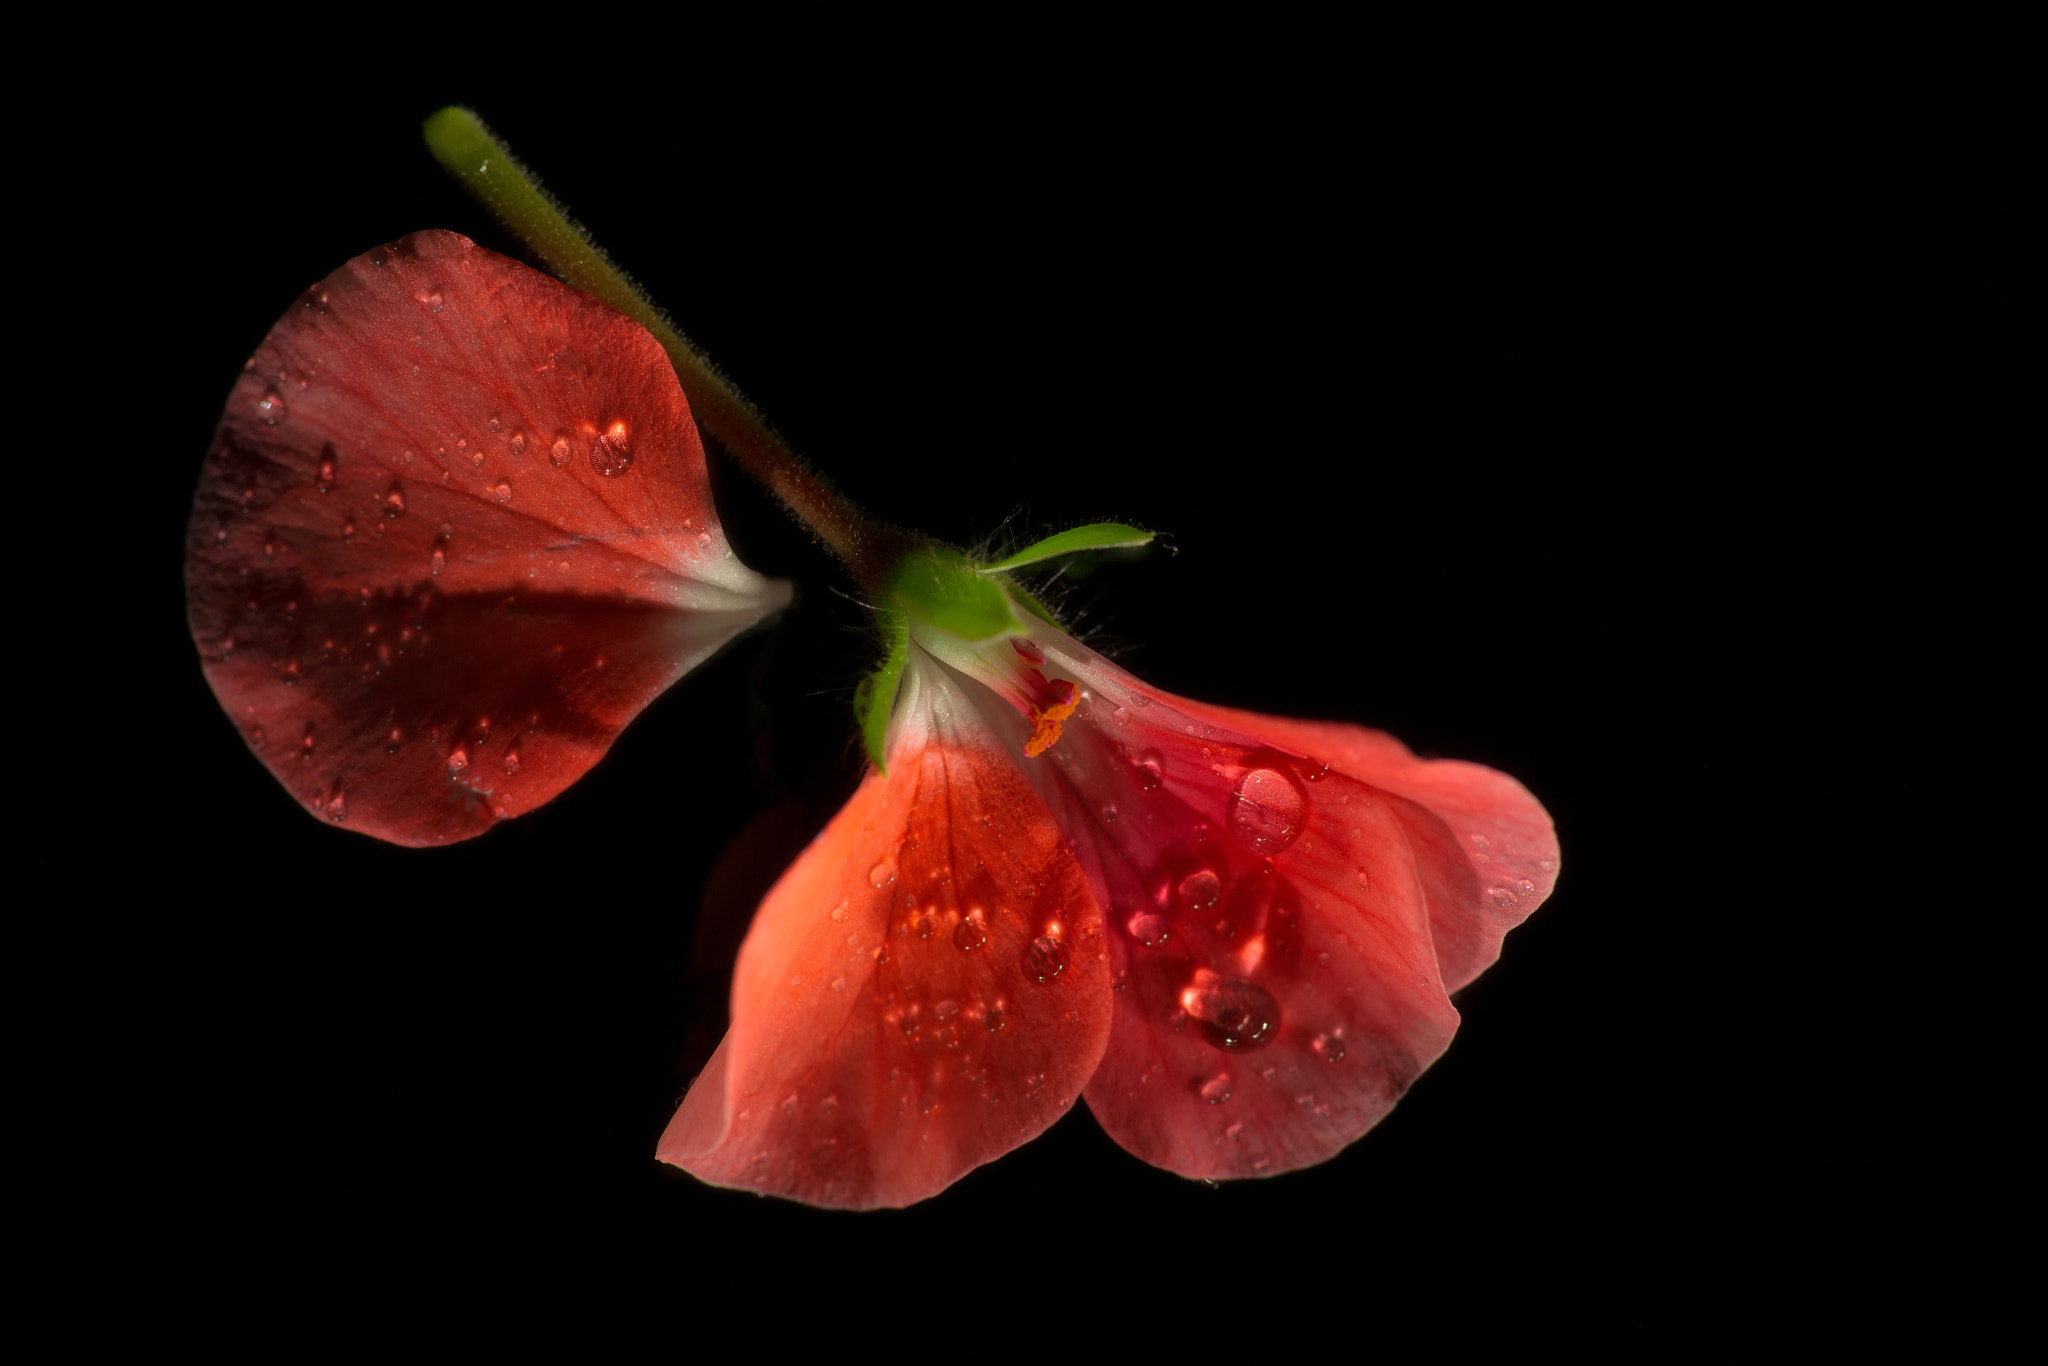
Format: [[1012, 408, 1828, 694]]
[[659, 663, 1110, 1208]]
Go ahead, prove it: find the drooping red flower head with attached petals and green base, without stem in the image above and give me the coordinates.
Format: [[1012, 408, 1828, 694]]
[[659, 555, 1559, 1208]]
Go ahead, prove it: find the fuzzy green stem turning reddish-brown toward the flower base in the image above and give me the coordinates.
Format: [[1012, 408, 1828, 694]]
[[426, 106, 911, 588]]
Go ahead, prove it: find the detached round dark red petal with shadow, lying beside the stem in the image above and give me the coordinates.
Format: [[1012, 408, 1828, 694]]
[[184, 231, 786, 844]]
